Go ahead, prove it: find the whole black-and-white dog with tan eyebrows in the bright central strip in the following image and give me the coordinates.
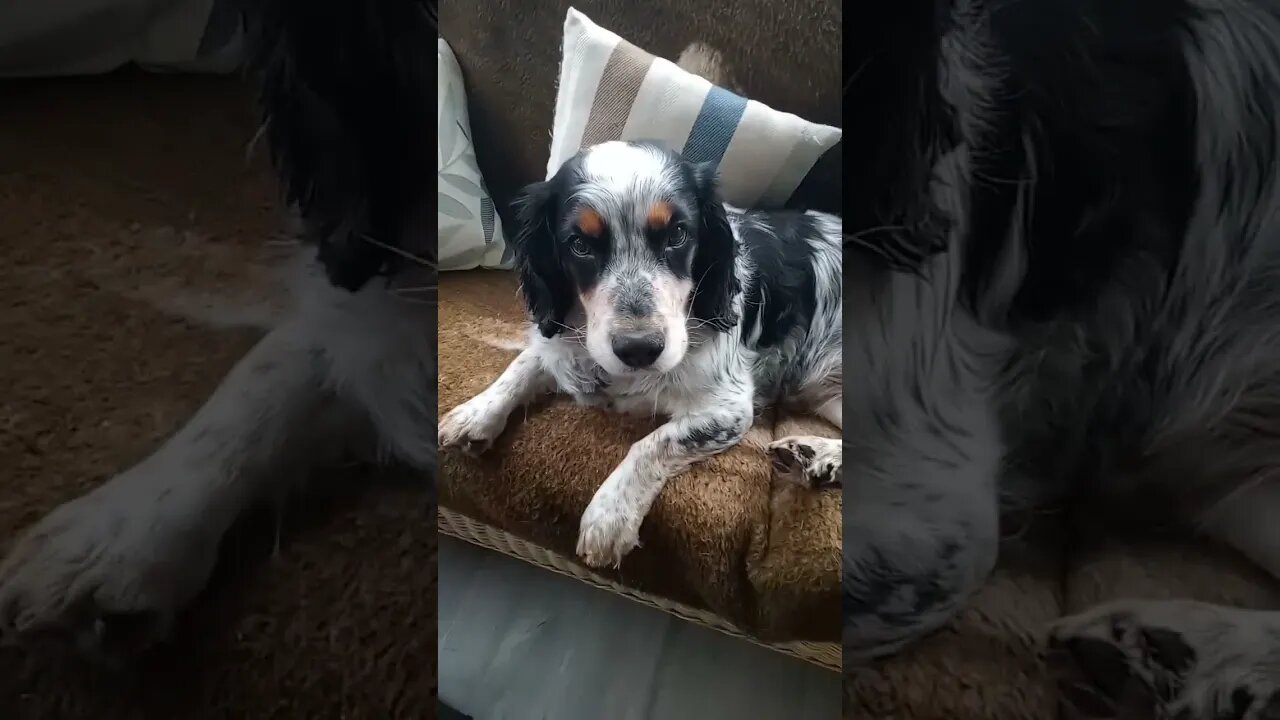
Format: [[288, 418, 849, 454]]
[[438, 141, 842, 568]]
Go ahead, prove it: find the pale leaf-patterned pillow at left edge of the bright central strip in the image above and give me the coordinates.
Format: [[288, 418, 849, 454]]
[[435, 38, 511, 270]]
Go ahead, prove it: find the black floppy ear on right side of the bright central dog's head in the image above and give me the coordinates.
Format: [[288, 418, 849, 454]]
[[691, 163, 739, 331]]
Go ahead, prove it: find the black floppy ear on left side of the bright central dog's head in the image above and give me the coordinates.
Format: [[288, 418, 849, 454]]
[[511, 182, 573, 337]]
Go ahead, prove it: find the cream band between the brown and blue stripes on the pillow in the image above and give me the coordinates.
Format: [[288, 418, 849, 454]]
[[622, 58, 712, 151]]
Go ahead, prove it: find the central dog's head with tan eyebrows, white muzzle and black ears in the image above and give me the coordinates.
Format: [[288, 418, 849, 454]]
[[512, 142, 737, 374]]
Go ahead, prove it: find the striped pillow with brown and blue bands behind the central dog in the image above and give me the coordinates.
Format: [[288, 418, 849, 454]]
[[547, 8, 841, 208]]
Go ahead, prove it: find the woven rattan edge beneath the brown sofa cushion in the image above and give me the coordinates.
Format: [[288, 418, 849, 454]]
[[436, 506, 841, 671]]
